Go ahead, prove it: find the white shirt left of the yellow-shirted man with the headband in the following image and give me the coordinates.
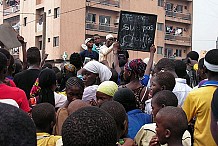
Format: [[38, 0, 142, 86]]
[[173, 78, 192, 107]]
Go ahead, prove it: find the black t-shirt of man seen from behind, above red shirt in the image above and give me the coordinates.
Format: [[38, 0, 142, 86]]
[[14, 69, 40, 99]]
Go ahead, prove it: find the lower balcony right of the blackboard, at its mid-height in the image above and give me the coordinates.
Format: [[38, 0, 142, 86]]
[[165, 34, 191, 47]]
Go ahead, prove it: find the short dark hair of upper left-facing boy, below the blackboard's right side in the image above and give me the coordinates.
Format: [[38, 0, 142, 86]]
[[155, 72, 176, 91]]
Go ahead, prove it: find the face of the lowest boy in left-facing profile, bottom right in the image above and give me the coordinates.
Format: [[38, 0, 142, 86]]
[[155, 113, 167, 145]]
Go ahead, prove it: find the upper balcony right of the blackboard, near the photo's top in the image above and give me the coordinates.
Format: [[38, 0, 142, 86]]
[[166, 10, 191, 24]]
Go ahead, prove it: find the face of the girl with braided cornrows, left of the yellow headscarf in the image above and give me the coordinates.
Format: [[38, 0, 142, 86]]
[[66, 86, 83, 102]]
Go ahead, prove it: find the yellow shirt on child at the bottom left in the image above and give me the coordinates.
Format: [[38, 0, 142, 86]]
[[36, 132, 61, 146]]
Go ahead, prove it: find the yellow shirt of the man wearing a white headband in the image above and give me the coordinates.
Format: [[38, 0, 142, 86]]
[[183, 86, 217, 146]]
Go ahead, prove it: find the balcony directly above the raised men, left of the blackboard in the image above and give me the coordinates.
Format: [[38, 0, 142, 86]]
[[86, 22, 118, 34]]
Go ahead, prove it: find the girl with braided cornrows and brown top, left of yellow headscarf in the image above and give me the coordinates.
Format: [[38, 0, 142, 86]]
[[55, 77, 84, 135]]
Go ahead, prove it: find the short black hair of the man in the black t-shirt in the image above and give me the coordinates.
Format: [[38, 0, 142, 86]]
[[27, 47, 41, 65]]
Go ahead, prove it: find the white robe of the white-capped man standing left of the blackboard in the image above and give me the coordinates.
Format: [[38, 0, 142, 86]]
[[99, 44, 114, 62]]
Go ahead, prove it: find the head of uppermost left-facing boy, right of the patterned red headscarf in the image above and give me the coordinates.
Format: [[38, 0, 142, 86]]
[[150, 72, 176, 96]]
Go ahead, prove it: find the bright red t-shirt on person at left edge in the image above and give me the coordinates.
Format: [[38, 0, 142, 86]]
[[0, 84, 30, 112]]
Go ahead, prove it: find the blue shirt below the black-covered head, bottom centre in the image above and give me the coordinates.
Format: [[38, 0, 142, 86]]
[[127, 109, 152, 139]]
